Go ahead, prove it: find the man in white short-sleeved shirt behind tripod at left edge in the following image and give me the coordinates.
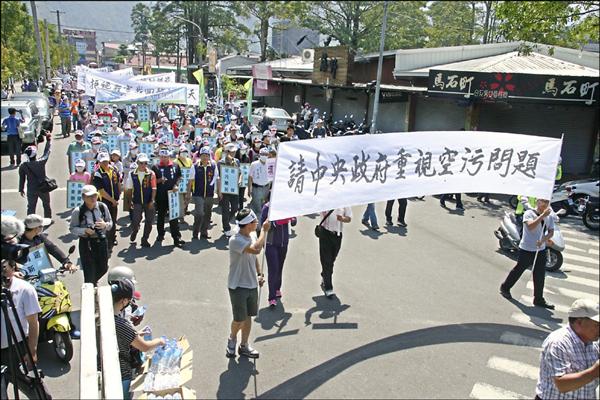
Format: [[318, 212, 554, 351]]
[[0, 216, 52, 399]]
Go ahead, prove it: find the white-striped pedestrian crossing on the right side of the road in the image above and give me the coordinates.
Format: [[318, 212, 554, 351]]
[[470, 230, 600, 399]]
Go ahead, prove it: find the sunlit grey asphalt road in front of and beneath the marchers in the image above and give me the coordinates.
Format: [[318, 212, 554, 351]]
[[1, 119, 598, 398]]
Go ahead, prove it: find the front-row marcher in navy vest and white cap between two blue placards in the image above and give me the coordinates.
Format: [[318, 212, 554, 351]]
[[187, 147, 219, 239]]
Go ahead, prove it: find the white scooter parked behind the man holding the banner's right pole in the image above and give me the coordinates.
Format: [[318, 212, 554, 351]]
[[494, 211, 565, 272]]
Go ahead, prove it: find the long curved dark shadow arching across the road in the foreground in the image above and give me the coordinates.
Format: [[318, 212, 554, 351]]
[[258, 323, 548, 399]]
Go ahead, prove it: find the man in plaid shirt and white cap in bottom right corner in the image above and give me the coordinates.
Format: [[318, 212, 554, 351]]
[[535, 299, 600, 399]]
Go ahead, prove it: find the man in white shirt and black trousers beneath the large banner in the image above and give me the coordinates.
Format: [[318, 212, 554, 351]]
[[319, 207, 352, 298]]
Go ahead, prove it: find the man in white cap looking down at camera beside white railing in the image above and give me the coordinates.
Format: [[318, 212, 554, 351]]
[[69, 185, 113, 286]]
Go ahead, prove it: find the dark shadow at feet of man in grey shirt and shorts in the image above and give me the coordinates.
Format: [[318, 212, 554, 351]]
[[216, 358, 258, 399]]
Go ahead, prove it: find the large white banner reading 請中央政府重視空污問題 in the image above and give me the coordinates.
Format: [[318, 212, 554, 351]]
[[269, 131, 562, 220]]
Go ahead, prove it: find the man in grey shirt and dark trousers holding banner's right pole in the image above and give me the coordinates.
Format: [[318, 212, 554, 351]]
[[500, 199, 554, 310]]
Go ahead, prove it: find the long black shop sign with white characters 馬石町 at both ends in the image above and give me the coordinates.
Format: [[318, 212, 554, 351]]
[[427, 69, 600, 105]]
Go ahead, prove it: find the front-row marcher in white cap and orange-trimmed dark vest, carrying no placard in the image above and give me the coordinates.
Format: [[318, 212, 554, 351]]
[[125, 153, 156, 247]]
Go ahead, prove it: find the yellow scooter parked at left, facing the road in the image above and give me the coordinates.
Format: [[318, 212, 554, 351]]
[[25, 246, 75, 363]]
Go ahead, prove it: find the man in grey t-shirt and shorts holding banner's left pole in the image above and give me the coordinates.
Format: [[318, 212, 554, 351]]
[[225, 208, 271, 358]]
